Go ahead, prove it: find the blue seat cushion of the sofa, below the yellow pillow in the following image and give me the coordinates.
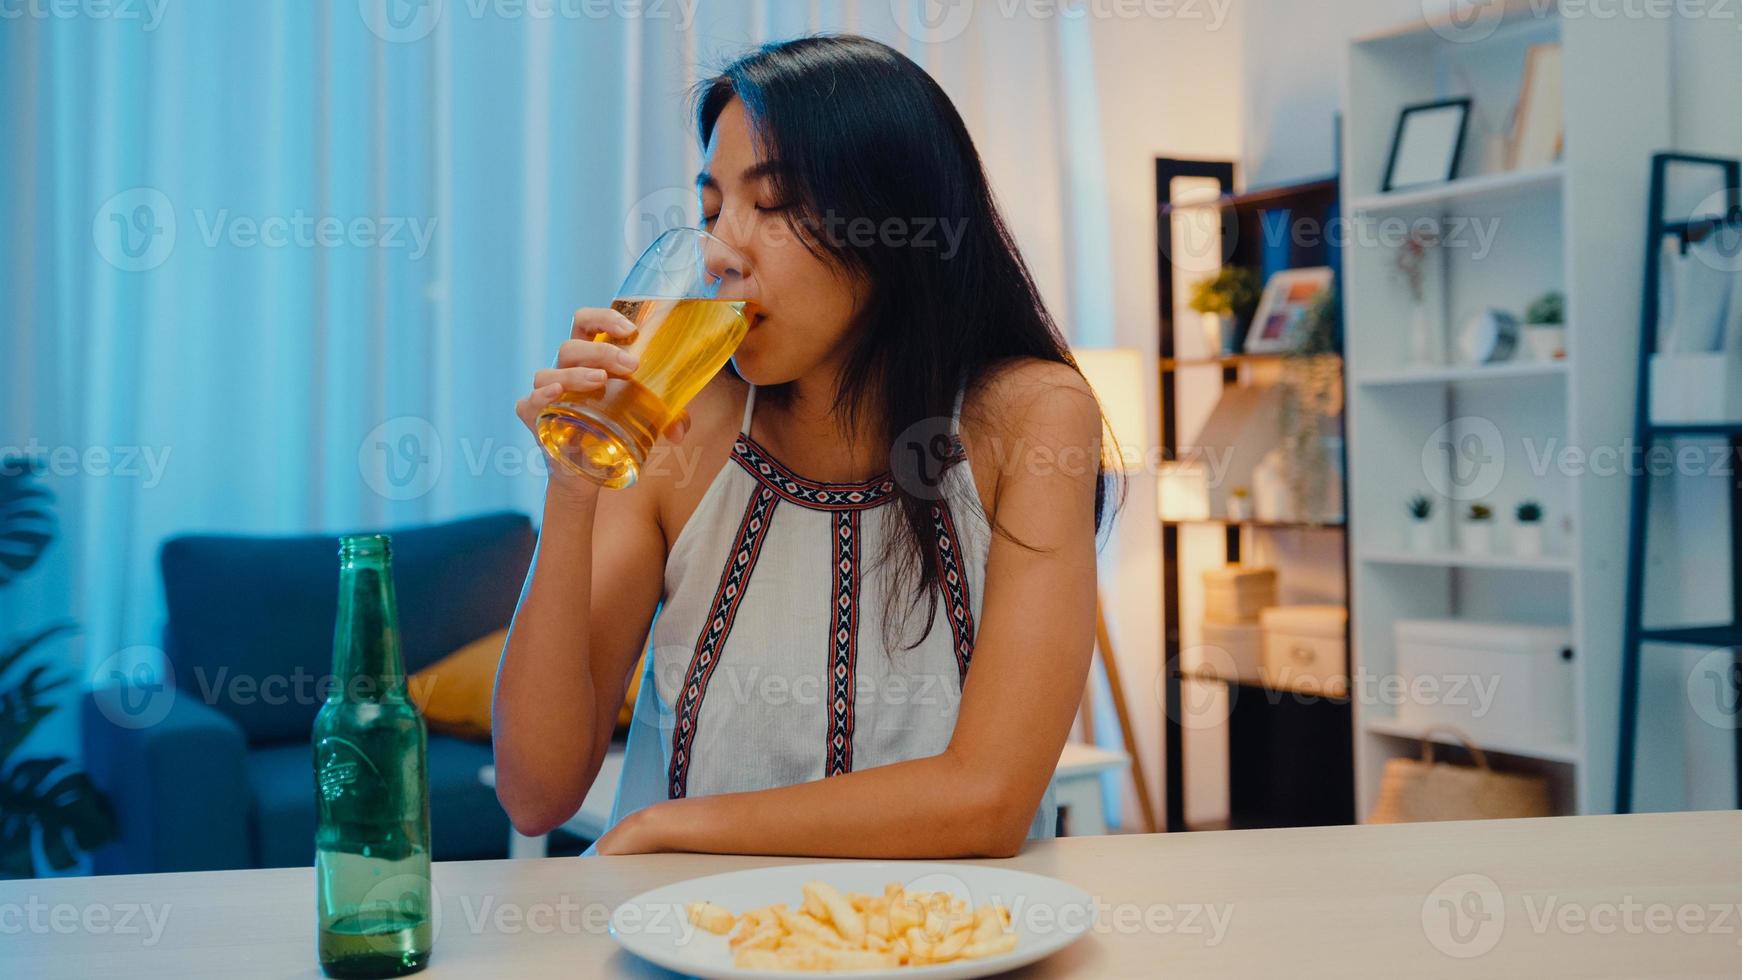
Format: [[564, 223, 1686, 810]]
[[246, 735, 509, 867]]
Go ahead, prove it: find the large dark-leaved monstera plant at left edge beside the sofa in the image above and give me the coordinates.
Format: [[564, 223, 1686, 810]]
[[0, 456, 115, 877]]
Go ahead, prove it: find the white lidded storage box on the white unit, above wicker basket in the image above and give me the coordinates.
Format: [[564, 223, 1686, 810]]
[[1395, 620, 1575, 745]]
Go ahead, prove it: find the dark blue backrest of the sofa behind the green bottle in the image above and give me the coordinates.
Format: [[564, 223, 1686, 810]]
[[160, 513, 533, 747]]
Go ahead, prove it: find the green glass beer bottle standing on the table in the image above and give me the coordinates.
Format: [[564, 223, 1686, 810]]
[[314, 534, 436, 977]]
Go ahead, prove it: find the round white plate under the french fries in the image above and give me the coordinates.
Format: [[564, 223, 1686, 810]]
[[611, 862, 1094, 980]]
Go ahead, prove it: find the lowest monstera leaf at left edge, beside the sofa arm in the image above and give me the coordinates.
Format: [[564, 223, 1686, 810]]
[[0, 755, 115, 877]]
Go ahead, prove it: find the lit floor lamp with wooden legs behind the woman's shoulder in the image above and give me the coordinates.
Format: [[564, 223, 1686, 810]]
[[1071, 348, 1157, 834]]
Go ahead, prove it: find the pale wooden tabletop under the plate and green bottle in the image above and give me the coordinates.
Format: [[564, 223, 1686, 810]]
[[0, 811, 1742, 980]]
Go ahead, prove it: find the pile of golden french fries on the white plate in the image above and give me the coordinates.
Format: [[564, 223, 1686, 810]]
[[688, 881, 1016, 970]]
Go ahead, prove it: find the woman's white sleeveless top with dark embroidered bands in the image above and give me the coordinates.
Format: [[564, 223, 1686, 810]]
[[592, 379, 1057, 837]]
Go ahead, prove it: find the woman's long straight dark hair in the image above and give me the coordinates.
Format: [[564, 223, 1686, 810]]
[[695, 35, 1110, 649]]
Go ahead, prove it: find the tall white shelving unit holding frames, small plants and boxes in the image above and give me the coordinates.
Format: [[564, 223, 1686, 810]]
[[1341, 0, 1671, 818]]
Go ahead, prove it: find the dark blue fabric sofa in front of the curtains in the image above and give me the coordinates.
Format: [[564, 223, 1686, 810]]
[[80, 513, 533, 874]]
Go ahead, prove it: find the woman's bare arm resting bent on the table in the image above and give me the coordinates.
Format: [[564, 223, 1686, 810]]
[[599, 362, 1101, 858]]
